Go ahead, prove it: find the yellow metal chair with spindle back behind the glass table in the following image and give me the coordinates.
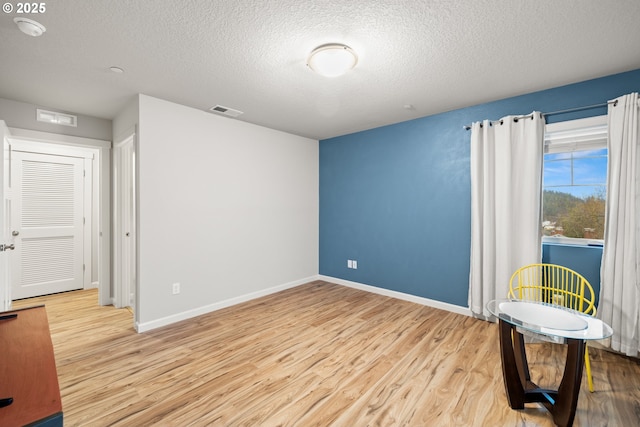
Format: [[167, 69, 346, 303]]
[[509, 264, 596, 393]]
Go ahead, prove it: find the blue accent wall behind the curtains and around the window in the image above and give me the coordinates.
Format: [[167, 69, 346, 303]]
[[320, 70, 640, 307]]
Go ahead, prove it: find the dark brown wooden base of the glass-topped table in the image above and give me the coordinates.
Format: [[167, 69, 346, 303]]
[[500, 319, 585, 427]]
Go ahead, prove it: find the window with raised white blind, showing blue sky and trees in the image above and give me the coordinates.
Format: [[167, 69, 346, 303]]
[[542, 116, 607, 244]]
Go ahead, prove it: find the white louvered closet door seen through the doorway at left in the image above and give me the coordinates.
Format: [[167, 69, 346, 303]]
[[11, 152, 84, 300]]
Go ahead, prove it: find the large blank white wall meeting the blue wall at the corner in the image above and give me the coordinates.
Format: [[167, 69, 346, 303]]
[[137, 95, 319, 331]]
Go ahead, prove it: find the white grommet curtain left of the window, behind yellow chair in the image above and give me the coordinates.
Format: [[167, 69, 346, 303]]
[[469, 112, 544, 317]]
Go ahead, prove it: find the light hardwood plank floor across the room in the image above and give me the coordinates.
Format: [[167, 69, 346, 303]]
[[14, 282, 640, 427]]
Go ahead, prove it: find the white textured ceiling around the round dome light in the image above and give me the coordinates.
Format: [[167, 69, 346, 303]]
[[0, 0, 640, 139]]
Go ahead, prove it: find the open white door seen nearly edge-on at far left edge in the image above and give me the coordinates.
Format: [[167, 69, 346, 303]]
[[0, 120, 12, 311]]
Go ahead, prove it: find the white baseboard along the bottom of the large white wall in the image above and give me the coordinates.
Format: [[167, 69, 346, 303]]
[[135, 276, 318, 332]]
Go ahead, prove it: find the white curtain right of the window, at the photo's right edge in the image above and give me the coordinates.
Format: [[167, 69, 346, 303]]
[[598, 93, 640, 357]]
